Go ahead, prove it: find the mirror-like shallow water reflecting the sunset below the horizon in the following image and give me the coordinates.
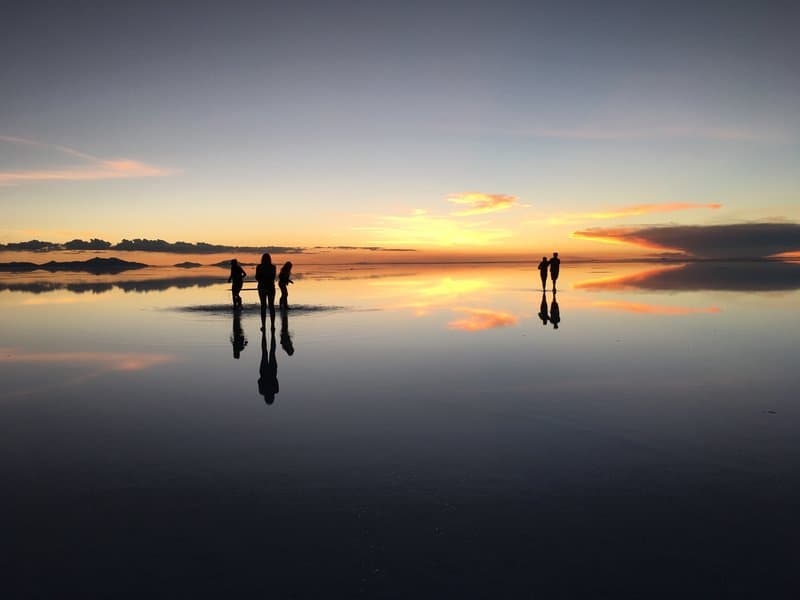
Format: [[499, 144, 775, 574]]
[[0, 263, 800, 598]]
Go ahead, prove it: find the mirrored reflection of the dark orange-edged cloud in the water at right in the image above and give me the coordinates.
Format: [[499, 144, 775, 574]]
[[575, 261, 800, 292]]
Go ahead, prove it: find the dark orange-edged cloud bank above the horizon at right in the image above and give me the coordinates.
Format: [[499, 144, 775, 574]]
[[575, 223, 800, 258]]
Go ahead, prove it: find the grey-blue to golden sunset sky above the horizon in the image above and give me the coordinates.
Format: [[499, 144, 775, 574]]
[[0, 0, 800, 256]]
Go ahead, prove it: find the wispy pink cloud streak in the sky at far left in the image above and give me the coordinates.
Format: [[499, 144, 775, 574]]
[[0, 136, 177, 185]]
